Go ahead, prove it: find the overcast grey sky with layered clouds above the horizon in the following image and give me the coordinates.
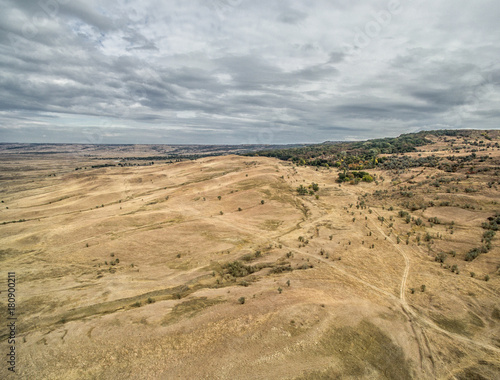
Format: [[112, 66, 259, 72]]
[[0, 0, 500, 144]]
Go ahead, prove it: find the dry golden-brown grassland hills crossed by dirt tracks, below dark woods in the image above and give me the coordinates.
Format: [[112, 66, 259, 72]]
[[0, 135, 500, 380]]
